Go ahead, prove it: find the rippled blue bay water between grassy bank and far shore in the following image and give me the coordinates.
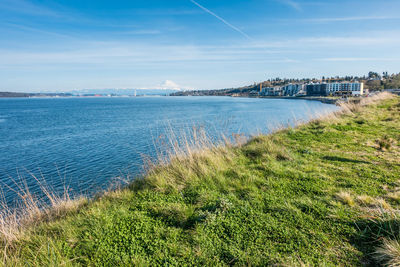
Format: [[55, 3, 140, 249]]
[[0, 97, 337, 202]]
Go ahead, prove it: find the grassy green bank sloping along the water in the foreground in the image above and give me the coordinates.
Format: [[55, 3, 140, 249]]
[[3, 94, 400, 266]]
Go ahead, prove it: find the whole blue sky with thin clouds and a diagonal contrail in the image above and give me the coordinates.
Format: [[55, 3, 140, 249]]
[[0, 0, 400, 92]]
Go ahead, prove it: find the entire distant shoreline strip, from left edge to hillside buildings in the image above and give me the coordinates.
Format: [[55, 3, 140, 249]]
[[0, 71, 400, 98]]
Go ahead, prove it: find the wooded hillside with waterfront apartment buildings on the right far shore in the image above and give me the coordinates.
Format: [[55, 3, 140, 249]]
[[172, 72, 400, 97]]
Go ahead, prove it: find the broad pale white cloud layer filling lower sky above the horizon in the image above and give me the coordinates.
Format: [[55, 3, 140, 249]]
[[0, 31, 400, 91]]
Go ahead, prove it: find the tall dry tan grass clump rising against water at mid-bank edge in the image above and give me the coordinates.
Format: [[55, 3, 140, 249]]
[[143, 127, 241, 194]]
